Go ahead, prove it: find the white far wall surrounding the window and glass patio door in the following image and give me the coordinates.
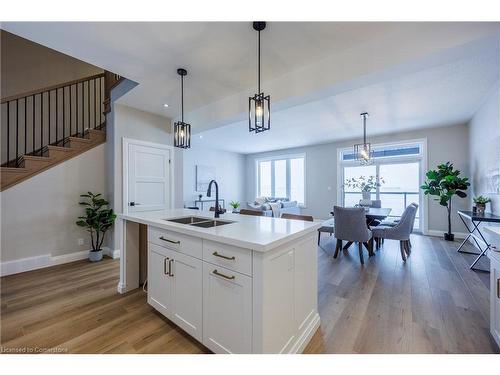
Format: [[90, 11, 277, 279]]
[[246, 125, 470, 232]]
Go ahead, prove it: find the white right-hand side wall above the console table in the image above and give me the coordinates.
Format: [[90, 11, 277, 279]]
[[469, 81, 500, 215]]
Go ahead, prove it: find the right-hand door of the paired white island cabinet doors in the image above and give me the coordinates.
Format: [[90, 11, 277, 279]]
[[171, 252, 203, 341]]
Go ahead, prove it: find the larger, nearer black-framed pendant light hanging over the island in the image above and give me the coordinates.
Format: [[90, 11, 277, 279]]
[[248, 22, 271, 133]]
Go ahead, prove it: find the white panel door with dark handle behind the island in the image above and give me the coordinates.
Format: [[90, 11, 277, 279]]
[[128, 144, 170, 212]]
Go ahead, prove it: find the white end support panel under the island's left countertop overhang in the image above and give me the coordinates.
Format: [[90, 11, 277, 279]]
[[118, 220, 140, 293]]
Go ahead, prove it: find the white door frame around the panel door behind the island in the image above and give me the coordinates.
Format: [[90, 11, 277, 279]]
[[122, 137, 175, 214]]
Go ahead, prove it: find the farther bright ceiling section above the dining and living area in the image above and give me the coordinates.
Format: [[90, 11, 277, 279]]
[[193, 39, 500, 154]]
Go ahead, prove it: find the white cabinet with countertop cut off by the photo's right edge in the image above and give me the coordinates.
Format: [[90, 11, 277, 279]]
[[486, 227, 500, 346]]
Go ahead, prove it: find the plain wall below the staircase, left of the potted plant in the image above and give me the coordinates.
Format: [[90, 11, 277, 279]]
[[0, 144, 108, 262]]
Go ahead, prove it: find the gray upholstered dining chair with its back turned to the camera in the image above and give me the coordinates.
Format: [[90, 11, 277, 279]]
[[333, 206, 373, 264]]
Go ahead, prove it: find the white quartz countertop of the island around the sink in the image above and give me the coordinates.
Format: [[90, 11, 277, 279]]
[[123, 209, 322, 252]]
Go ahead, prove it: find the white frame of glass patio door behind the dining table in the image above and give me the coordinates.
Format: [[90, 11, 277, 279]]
[[337, 138, 428, 234]]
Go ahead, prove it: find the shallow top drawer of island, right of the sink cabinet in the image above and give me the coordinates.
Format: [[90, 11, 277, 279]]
[[203, 240, 252, 276]]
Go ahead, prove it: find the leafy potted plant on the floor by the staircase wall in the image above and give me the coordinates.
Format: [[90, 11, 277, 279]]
[[76, 191, 116, 262]]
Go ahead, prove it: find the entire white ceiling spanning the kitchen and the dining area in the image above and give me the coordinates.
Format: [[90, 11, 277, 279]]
[[2, 22, 500, 153]]
